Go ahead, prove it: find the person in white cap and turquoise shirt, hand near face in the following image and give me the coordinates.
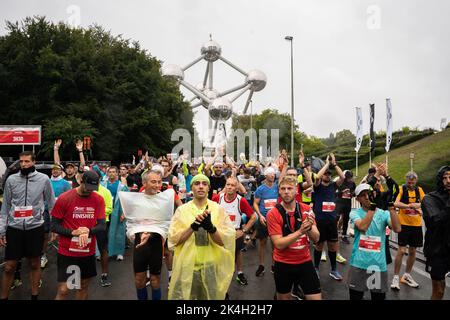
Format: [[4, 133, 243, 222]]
[[348, 183, 401, 300]]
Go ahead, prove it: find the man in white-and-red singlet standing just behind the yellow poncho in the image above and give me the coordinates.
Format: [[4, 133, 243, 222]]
[[212, 177, 256, 286]]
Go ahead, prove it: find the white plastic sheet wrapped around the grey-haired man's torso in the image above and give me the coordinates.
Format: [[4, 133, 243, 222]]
[[119, 189, 175, 240]]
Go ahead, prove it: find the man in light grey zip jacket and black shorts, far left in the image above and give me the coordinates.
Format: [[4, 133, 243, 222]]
[[0, 151, 55, 300]]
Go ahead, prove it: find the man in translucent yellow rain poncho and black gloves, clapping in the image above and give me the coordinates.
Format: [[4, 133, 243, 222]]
[[168, 174, 236, 300]]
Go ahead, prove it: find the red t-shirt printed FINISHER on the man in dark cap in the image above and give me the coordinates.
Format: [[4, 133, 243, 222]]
[[52, 189, 105, 257]]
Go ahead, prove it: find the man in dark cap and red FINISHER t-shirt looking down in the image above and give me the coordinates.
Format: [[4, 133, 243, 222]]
[[52, 171, 106, 300]]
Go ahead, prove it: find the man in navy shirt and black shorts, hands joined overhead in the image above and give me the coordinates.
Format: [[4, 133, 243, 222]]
[[313, 154, 345, 281]]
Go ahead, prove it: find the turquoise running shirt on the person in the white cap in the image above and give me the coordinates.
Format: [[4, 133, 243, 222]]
[[350, 208, 391, 272]]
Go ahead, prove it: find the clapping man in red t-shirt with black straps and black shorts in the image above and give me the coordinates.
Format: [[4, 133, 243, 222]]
[[267, 176, 322, 300]]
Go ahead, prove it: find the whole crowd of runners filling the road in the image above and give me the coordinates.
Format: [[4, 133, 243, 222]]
[[0, 140, 450, 300]]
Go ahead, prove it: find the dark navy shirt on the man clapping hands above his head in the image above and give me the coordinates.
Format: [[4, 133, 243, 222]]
[[312, 182, 338, 221]]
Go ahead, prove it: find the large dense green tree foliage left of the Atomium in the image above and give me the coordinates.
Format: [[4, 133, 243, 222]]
[[0, 17, 194, 162]]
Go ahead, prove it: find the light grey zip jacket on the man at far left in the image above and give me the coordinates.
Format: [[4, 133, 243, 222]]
[[0, 171, 55, 236]]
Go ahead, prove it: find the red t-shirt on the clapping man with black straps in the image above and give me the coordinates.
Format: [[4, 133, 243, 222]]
[[267, 203, 315, 264]]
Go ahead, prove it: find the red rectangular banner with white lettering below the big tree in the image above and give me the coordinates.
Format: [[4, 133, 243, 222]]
[[0, 126, 41, 145]]
